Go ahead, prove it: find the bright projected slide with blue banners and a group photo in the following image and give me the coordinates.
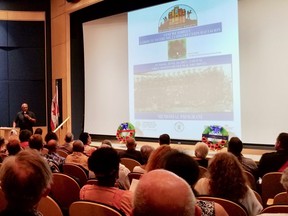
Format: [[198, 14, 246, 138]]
[[128, 0, 241, 139]]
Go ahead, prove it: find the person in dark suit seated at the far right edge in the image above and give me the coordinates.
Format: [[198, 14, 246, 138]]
[[258, 133, 288, 177]]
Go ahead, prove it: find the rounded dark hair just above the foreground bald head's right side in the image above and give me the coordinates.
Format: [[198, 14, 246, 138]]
[[163, 151, 200, 187]]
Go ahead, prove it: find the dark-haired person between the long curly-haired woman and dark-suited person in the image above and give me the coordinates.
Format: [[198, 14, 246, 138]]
[[228, 137, 258, 179]]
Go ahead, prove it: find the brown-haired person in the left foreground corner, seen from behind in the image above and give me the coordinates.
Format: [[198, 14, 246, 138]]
[[0, 149, 52, 216]]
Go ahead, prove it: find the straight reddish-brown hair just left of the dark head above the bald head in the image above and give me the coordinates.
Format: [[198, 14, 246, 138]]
[[145, 145, 177, 172]]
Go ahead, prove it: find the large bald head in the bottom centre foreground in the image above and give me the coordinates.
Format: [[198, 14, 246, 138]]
[[133, 169, 196, 216]]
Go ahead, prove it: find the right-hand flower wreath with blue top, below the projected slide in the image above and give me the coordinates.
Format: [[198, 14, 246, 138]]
[[202, 125, 229, 151]]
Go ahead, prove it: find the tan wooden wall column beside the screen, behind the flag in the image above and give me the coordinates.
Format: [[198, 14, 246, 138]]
[[51, 0, 100, 140]]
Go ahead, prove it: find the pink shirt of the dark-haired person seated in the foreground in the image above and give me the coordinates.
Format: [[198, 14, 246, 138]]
[[80, 184, 133, 216]]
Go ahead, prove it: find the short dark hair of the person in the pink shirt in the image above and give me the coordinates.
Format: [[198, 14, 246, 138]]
[[88, 148, 120, 186]]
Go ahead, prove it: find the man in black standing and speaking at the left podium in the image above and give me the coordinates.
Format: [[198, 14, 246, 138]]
[[13, 103, 36, 134]]
